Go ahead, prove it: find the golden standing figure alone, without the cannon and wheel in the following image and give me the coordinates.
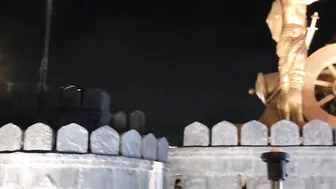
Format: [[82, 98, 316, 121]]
[[266, 0, 317, 125]]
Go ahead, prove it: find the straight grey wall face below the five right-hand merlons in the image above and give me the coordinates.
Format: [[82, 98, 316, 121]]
[[169, 146, 336, 189]]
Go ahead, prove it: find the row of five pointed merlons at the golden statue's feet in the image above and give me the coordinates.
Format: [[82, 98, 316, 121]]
[[183, 120, 334, 147]]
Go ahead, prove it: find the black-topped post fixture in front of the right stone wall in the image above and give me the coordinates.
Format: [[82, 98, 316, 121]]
[[261, 151, 289, 189]]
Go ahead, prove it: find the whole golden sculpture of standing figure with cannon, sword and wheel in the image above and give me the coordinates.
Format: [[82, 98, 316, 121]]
[[249, 0, 336, 129]]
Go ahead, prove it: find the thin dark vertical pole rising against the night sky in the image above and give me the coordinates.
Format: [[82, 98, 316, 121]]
[[39, 0, 53, 94]]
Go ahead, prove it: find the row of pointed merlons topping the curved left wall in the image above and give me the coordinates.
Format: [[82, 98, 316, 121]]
[[0, 123, 169, 163]]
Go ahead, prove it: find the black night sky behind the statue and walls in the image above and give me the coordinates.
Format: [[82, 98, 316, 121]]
[[0, 0, 336, 143]]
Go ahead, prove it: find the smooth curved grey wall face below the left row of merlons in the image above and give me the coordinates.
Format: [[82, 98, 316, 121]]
[[0, 152, 168, 189]]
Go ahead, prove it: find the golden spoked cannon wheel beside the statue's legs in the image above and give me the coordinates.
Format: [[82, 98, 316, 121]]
[[302, 44, 336, 128]]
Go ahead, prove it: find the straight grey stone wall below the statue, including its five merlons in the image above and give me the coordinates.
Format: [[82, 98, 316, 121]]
[[169, 120, 336, 189]]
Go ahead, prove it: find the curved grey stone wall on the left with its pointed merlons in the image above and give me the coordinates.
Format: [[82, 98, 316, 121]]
[[0, 123, 169, 189]]
